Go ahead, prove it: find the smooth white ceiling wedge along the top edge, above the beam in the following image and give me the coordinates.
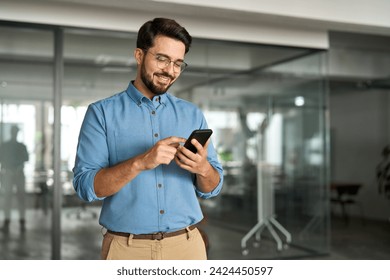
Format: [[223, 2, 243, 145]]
[[35, 0, 390, 34]]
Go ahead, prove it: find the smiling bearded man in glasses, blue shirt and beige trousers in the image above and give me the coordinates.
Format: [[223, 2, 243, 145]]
[[73, 18, 223, 259]]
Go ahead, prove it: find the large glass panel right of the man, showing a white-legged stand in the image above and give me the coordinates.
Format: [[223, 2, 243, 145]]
[[195, 50, 330, 259]]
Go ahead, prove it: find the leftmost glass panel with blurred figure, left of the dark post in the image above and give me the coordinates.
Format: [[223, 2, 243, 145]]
[[0, 26, 54, 259]]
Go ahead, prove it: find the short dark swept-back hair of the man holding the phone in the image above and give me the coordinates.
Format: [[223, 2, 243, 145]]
[[137, 18, 192, 53]]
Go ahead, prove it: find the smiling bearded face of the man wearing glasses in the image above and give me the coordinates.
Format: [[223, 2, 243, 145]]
[[140, 36, 185, 97]]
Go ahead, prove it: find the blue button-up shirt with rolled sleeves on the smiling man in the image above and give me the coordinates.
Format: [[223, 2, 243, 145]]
[[73, 83, 223, 234]]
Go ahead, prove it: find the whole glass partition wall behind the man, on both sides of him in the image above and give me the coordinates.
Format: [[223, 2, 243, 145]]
[[0, 22, 329, 259]]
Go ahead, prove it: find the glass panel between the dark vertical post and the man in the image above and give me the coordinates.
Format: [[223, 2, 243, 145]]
[[61, 28, 135, 259]]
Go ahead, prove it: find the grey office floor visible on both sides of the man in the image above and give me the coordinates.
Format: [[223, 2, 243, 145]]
[[0, 207, 390, 260]]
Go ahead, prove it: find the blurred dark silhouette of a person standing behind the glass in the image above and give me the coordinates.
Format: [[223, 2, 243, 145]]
[[0, 125, 28, 232]]
